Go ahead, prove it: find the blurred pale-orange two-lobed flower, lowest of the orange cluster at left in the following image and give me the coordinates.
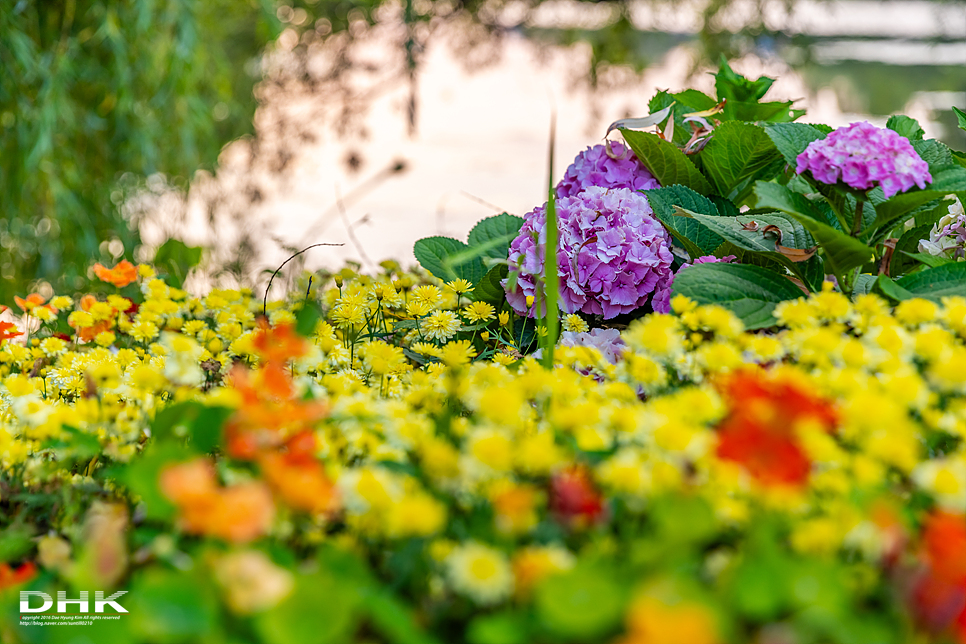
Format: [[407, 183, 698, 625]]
[[160, 459, 275, 543]]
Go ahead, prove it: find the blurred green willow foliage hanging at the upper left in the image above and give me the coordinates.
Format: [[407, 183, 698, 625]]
[[0, 0, 280, 301]]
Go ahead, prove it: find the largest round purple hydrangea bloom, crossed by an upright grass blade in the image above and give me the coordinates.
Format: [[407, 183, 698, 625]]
[[504, 187, 673, 319]]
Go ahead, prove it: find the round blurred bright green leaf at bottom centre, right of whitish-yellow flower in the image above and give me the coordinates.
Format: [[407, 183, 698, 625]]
[[535, 565, 627, 641]]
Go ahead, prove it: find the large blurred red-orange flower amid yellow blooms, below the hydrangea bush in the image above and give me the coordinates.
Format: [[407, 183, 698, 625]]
[[717, 371, 838, 486]]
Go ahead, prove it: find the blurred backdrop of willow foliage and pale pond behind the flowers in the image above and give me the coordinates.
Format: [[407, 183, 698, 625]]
[[0, 0, 966, 302]]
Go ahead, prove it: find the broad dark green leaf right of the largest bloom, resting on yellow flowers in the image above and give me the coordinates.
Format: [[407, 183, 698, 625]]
[[673, 264, 804, 329]]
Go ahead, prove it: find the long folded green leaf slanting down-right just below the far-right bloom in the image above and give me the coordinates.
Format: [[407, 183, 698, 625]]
[[755, 181, 874, 275]]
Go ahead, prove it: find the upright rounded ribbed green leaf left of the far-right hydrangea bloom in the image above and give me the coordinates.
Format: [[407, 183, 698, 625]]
[[701, 121, 784, 202]]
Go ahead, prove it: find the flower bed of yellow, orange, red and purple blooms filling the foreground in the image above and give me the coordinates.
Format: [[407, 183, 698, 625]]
[[0, 64, 966, 644]]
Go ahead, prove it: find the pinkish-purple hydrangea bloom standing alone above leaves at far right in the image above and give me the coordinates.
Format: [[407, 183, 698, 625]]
[[796, 121, 932, 199]]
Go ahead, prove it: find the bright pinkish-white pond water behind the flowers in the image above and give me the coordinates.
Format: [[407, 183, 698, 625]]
[[144, 2, 966, 288]]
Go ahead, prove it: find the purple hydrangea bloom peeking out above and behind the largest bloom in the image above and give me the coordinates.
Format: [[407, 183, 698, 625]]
[[557, 143, 661, 198]]
